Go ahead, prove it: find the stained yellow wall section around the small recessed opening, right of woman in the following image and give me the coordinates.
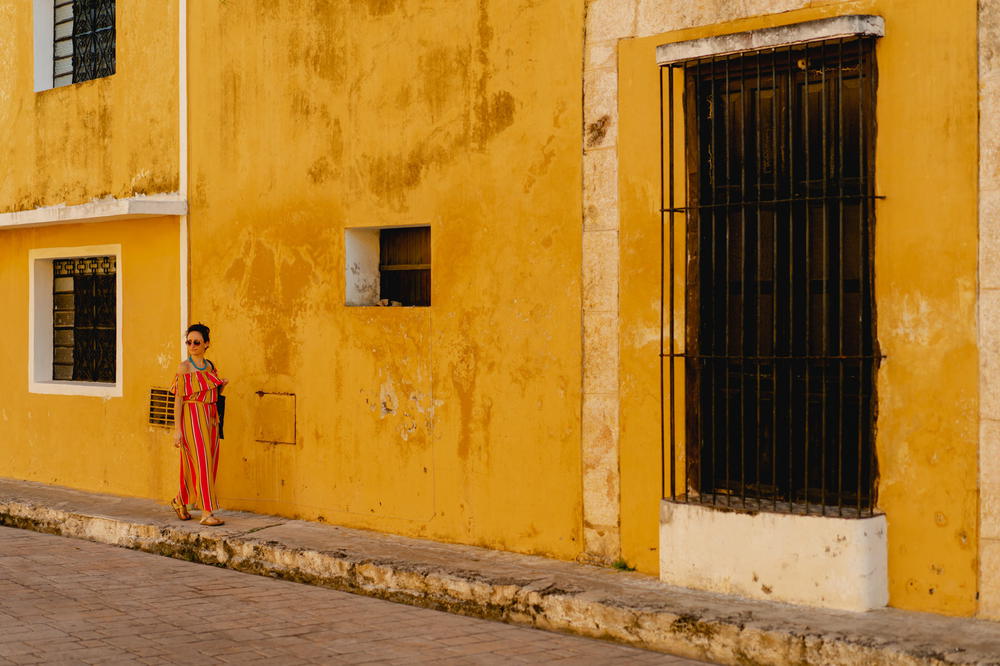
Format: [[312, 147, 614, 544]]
[[189, 0, 583, 557]]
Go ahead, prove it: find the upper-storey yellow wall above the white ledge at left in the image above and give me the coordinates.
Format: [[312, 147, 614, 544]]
[[0, 0, 178, 211]]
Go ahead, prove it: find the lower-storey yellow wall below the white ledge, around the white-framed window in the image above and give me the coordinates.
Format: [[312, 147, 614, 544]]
[[0, 218, 180, 498]]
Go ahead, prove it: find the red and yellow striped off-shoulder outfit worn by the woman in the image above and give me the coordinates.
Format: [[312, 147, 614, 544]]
[[170, 367, 222, 512]]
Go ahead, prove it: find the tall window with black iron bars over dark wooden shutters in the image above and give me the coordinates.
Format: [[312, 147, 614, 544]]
[[660, 38, 880, 517]]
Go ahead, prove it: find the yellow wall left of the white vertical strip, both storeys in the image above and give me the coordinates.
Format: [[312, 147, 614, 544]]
[[0, 0, 180, 497]]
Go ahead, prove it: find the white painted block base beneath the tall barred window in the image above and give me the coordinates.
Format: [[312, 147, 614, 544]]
[[660, 500, 889, 611]]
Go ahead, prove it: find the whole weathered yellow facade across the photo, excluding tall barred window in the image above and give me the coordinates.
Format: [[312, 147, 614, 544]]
[[0, 0, 1000, 618]]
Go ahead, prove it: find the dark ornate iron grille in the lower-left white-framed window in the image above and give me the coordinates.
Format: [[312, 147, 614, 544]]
[[52, 256, 117, 382]]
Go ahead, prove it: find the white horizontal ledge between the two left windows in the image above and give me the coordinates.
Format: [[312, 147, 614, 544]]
[[0, 195, 187, 231]]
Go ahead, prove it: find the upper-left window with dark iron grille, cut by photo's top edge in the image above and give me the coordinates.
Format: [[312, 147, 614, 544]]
[[52, 0, 115, 86]]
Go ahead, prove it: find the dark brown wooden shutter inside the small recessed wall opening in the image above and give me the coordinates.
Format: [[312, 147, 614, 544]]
[[379, 227, 431, 305]]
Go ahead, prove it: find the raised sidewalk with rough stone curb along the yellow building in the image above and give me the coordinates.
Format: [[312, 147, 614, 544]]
[[0, 479, 1000, 666]]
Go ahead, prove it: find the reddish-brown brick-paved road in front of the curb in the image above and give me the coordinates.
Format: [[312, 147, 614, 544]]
[[0, 527, 698, 666]]
